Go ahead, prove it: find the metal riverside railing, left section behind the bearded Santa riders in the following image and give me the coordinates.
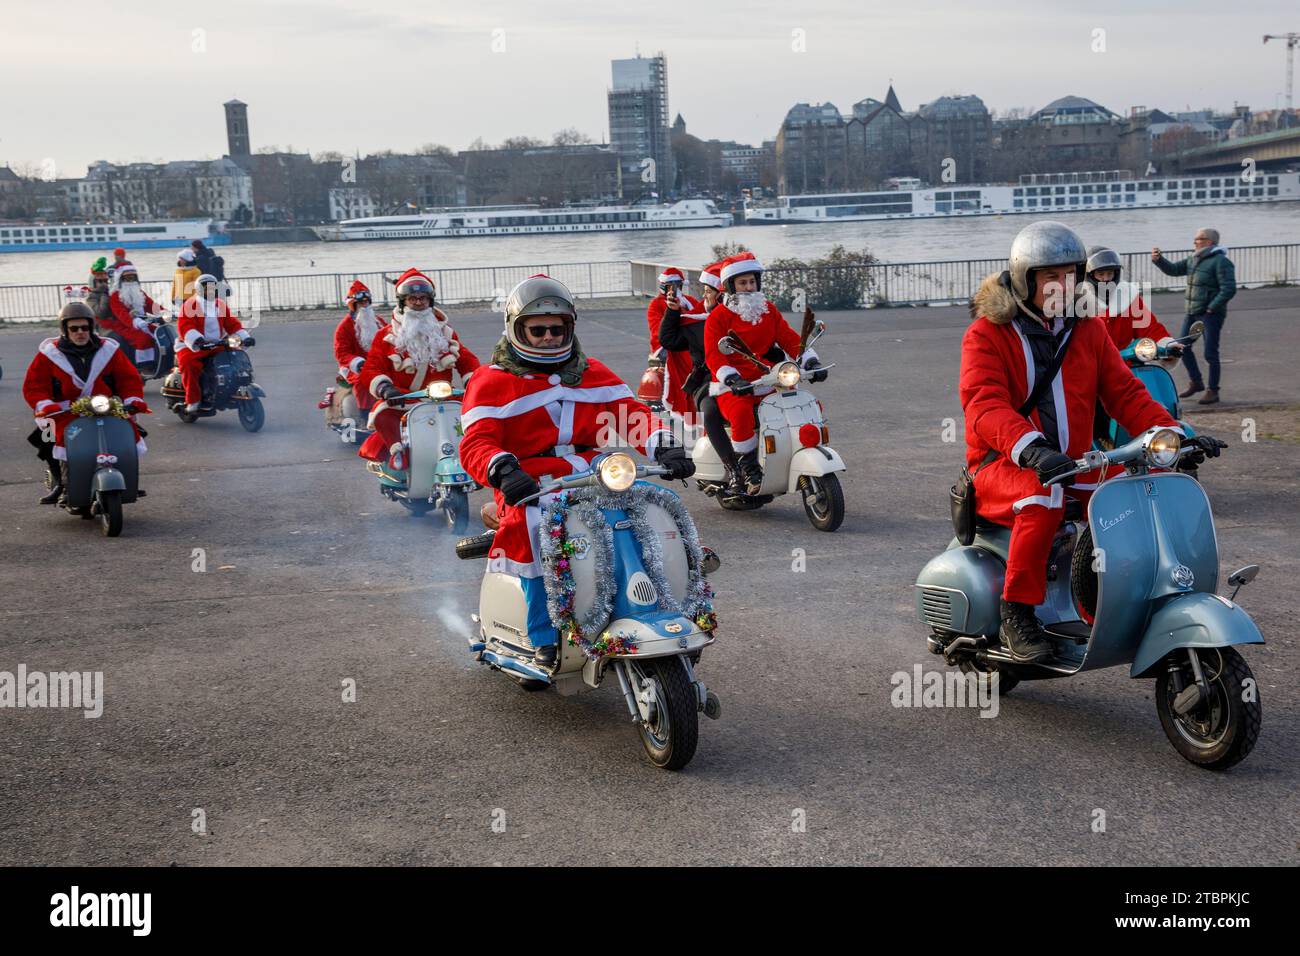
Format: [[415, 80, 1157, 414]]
[[0, 259, 632, 323]]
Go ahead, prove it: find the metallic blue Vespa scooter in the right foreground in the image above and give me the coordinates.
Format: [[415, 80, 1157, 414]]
[[915, 428, 1264, 770]]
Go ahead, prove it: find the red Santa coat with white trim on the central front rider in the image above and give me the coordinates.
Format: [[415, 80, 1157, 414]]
[[460, 359, 668, 578]]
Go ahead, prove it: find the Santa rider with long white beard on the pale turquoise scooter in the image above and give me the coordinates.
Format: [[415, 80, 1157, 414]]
[[358, 269, 478, 471]]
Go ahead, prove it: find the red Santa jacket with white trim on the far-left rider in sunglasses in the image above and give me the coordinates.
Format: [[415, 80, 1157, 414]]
[[22, 338, 148, 459]]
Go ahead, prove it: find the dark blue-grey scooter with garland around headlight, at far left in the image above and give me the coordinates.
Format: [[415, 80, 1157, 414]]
[[64, 395, 144, 537]]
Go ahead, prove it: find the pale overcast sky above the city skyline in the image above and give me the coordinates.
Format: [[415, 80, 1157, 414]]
[[0, 0, 1300, 177]]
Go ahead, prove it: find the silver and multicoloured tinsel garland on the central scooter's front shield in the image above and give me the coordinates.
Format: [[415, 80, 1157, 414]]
[[538, 483, 718, 659]]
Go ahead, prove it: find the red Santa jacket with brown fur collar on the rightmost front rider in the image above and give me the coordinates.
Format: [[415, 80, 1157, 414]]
[[958, 276, 1178, 515]]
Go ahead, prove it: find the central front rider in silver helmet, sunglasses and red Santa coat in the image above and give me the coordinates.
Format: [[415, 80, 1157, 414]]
[[460, 276, 696, 666]]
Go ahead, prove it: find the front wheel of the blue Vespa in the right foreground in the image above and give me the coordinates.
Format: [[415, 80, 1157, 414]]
[[1156, 648, 1264, 770]]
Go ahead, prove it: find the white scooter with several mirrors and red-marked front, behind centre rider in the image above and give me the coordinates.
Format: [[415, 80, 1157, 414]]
[[690, 321, 844, 531]]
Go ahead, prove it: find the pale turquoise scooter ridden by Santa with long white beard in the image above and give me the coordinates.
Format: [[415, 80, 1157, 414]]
[[367, 381, 478, 535]]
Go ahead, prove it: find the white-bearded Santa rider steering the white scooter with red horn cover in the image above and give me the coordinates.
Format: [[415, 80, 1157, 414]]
[[705, 252, 820, 494]]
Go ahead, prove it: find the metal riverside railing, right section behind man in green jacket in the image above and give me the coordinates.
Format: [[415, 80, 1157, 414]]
[[632, 243, 1300, 308]]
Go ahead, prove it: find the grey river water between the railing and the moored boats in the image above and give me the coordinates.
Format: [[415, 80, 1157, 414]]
[[0, 203, 1300, 285]]
